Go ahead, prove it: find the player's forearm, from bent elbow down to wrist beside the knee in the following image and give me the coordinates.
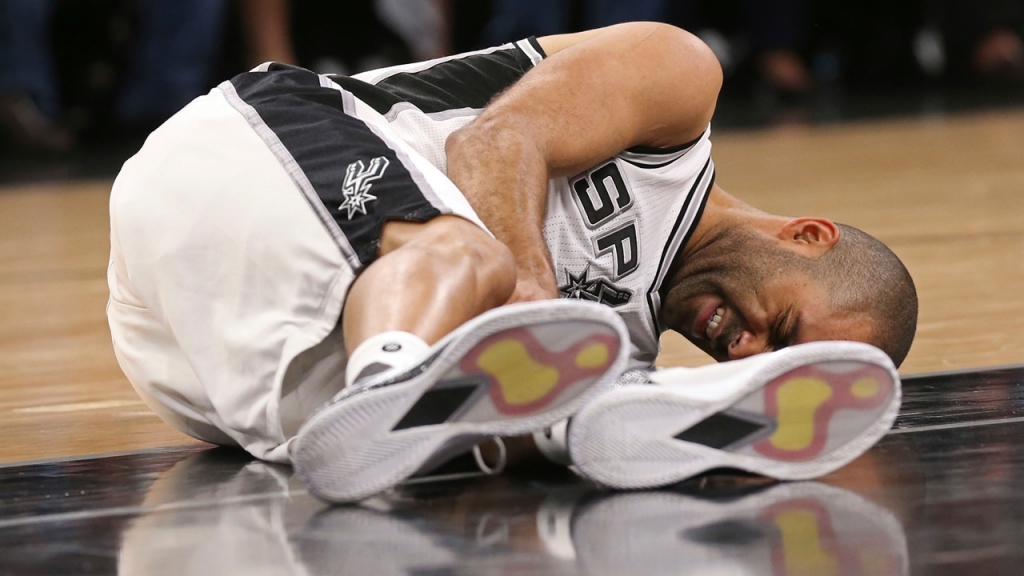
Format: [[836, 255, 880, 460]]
[[445, 116, 557, 296]]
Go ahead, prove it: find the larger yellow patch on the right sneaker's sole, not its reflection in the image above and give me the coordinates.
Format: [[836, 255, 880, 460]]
[[769, 378, 831, 451]]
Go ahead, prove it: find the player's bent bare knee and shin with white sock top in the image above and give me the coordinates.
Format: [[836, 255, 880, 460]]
[[342, 215, 516, 383]]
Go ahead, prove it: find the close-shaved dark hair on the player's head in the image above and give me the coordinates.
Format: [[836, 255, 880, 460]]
[[809, 223, 918, 366]]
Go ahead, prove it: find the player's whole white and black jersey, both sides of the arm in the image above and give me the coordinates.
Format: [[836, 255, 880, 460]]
[[329, 39, 715, 367]]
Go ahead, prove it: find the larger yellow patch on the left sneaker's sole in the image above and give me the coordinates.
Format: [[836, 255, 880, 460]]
[[476, 338, 559, 405]]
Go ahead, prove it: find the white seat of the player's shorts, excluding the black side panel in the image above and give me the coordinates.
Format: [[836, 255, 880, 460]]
[[109, 85, 355, 463]]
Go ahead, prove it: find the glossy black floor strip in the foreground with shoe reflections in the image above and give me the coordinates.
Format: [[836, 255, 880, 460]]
[[0, 368, 1024, 576]]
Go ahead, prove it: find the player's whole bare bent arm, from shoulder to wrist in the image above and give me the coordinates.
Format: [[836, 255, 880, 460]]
[[445, 23, 722, 299]]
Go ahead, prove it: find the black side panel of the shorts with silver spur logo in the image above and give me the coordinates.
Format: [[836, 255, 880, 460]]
[[230, 65, 440, 269]]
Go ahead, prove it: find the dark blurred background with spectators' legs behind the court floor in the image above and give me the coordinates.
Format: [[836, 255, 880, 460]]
[[0, 0, 1024, 182]]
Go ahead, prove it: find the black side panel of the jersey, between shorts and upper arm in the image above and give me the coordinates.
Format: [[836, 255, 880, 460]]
[[328, 45, 534, 114]]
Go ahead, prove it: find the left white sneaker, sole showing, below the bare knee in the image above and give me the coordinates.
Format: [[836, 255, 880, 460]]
[[291, 300, 630, 502]]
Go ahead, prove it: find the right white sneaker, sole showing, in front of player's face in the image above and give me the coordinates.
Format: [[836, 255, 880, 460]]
[[568, 341, 900, 488]]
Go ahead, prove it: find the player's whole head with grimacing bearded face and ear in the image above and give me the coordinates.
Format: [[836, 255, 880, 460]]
[[663, 215, 918, 366]]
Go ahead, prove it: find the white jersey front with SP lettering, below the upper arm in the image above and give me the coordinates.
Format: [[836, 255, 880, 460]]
[[544, 138, 715, 364]]
